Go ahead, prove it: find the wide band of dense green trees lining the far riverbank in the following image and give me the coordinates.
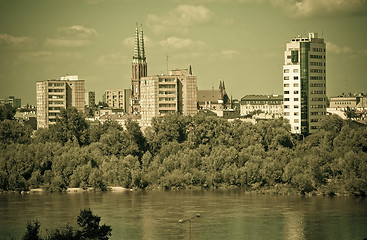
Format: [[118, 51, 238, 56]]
[[0, 109, 367, 195]]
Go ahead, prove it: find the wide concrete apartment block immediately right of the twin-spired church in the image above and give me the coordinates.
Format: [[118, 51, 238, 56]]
[[140, 67, 197, 127]]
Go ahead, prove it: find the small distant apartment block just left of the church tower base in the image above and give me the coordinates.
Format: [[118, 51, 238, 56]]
[[103, 89, 130, 113]]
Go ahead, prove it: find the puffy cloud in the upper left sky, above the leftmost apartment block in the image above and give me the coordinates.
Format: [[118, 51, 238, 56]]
[[45, 25, 98, 48]]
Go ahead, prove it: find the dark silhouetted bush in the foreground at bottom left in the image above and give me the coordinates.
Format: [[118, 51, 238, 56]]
[[22, 209, 112, 240]]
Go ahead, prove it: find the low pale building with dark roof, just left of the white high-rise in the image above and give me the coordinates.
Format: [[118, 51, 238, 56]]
[[241, 95, 283, 118]]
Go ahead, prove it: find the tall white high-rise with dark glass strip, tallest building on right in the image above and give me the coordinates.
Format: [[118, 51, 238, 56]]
[[283, 33, 327, 135]]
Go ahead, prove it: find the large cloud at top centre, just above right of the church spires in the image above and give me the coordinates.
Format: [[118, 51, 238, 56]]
[[146, 5, 213, 33]]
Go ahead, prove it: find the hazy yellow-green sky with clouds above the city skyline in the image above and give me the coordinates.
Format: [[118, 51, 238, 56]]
[[0, 0, 367, 104]]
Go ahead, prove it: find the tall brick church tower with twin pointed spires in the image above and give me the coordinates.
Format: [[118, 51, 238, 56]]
[[130, 26, 148, 114]]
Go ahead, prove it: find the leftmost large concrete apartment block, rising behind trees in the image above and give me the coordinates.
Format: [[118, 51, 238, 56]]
[[36, 75, 84, 128]]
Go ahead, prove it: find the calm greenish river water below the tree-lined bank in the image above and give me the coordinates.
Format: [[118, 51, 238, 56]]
[[0, 190, 367, 240]]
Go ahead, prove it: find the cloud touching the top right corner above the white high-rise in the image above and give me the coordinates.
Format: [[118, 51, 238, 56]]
[[269, 0, 367, 17]]
